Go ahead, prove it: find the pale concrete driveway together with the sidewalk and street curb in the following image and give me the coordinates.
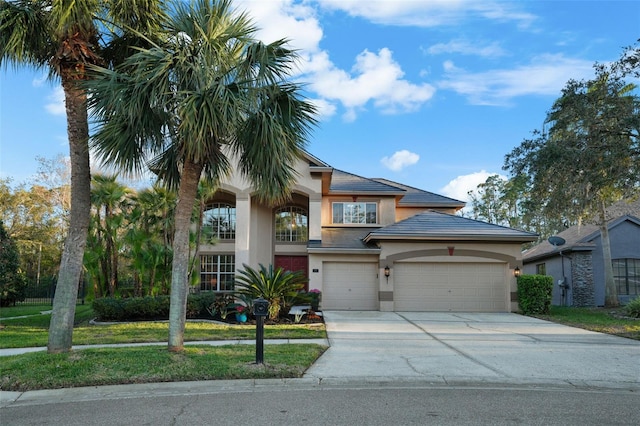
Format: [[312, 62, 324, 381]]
[[0, 311, 640, 407]]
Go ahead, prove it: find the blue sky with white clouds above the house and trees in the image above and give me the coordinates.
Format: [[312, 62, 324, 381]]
[[0, 0, 640, 205]]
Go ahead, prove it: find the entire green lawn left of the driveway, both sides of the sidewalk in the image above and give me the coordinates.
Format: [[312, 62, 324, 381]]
[[0, 306, 326, 391]]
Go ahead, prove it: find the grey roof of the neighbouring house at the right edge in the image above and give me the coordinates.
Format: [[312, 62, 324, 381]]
[[522, 215, 640, 262]]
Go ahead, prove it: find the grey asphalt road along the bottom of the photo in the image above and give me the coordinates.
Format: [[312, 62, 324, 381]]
[[0, 383, 640, 426]]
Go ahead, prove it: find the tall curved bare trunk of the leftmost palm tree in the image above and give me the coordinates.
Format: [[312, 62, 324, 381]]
[[47, 76, 91, 353]]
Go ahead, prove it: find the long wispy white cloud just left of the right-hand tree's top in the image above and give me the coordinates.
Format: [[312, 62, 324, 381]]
[[438, 55, 593, 105]]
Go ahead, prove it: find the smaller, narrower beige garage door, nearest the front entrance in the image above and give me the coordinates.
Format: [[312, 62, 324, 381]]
[[321, 262, 378, 311]]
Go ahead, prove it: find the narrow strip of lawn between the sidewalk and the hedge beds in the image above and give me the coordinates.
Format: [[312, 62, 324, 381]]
[[0, 306, 326, 349]]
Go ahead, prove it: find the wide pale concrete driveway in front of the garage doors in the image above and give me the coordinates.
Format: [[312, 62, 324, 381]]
[[305, 311, 640, 389]]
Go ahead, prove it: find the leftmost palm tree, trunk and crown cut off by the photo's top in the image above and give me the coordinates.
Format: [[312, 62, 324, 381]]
[[0, 0, 163, 353]]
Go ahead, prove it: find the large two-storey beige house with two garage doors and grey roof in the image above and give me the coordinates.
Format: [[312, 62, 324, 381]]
[[200, 153, 537, 312]]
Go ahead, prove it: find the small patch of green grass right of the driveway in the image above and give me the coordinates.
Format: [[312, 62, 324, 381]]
[[535, 306, 640, 340]]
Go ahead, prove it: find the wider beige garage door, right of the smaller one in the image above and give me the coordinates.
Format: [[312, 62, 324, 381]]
[[393, 263, 508, 312]]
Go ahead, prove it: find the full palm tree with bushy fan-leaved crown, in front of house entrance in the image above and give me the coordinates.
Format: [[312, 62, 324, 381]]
[[91, 0, 315, 351]]
